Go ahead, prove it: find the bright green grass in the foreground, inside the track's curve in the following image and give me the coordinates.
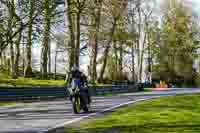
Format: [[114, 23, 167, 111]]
[[66, 95, 200, 133]]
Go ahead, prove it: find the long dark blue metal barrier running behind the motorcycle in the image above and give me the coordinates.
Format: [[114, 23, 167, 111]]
[[0, 85, 140, 100]]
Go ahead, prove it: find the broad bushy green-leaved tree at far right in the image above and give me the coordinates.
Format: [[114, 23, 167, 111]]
[[152, 0, 196, 84]]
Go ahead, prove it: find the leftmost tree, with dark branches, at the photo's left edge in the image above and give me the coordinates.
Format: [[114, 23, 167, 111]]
[[1, 0, 23, 78]]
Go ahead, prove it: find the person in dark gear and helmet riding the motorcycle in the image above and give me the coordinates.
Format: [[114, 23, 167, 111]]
[[69, 65, 91, 104]]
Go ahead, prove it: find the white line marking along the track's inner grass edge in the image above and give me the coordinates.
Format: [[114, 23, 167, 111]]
[[39, 97, 153, 133]]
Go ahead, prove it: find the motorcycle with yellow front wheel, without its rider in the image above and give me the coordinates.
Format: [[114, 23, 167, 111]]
[[71, 79, 89, 114]]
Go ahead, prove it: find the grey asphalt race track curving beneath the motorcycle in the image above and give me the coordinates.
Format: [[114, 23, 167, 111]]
[[0, 88, 200, 133]]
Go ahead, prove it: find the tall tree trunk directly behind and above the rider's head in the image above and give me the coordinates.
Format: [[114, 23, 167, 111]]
[[65, 0, 87, 81]]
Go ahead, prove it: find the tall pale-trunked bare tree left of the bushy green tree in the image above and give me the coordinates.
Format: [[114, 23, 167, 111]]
[[127, 0, 156, 82]]
